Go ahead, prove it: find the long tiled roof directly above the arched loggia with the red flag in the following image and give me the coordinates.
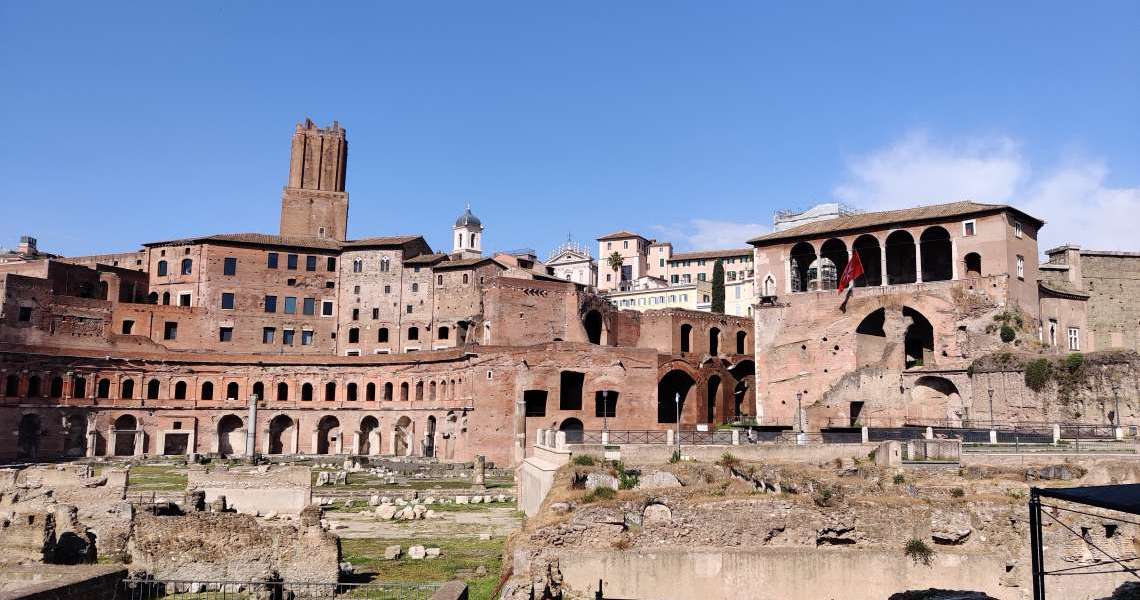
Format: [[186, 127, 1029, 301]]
[[748, 202, 1044, 245]]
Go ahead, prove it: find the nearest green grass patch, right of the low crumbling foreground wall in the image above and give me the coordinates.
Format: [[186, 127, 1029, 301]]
[[341, 537, 506, 600]]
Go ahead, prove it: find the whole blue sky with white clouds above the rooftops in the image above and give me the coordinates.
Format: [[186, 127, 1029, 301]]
[[0, 1, 1140, 256]]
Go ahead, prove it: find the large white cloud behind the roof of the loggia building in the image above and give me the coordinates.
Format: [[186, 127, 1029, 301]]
[[833, 132, 1140, 250]]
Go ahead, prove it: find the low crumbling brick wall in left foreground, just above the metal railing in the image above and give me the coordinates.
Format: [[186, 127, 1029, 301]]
[[131, 512, 340, 582]]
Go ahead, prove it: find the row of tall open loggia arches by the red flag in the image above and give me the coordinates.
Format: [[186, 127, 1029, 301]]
[[784, 225, 982, 295]]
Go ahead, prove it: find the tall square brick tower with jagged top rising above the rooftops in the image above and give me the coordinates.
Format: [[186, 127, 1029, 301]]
[[282, 119, 349, 242]]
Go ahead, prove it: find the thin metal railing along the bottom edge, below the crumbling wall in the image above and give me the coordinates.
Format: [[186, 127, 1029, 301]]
[[119, 578, 441, 600]]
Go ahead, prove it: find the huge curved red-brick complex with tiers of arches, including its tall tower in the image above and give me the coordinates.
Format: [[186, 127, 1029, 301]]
[[0, 121, 756, 463]]
